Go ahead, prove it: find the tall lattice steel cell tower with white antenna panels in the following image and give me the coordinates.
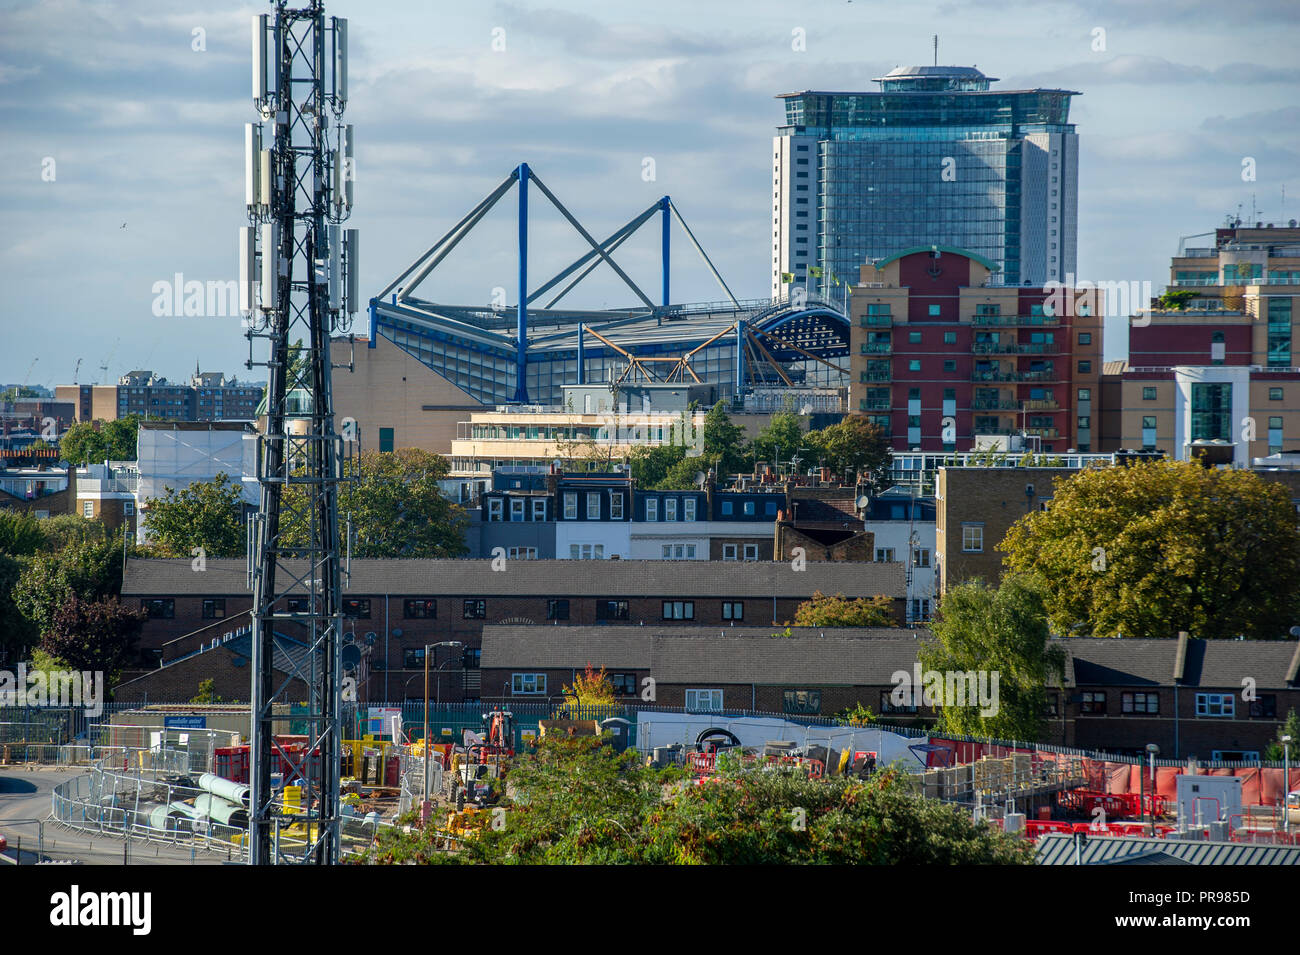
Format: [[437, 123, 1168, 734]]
[[239, 0, 360, 865]]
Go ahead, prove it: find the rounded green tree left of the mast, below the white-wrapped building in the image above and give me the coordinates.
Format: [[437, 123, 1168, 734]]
[[144, 474, 246, 557]]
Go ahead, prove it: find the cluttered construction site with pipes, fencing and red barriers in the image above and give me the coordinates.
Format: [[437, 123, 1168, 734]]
[[0, 704, 1300, 864]]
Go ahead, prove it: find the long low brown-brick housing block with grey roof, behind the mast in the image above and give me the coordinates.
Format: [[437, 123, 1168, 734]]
[[122, 560, 906, 702]]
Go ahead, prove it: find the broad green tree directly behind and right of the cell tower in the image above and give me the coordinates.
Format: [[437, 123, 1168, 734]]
[[281, 448, 467, 557]]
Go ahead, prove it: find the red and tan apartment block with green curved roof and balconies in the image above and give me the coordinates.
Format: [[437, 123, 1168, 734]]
[[849, 246, 1102, 451]]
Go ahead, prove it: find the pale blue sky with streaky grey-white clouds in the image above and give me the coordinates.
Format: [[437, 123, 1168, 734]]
[[0, 0, 1300, 387]]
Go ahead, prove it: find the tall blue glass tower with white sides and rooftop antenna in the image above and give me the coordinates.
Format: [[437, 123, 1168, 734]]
[[772, 66, 1078, 298]]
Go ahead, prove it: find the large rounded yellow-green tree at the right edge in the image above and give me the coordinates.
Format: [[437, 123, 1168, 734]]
[[1001, 461, 1300, 638]]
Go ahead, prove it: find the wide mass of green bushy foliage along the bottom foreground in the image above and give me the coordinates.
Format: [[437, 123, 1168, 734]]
[[365, 737, 1032, 865]]
